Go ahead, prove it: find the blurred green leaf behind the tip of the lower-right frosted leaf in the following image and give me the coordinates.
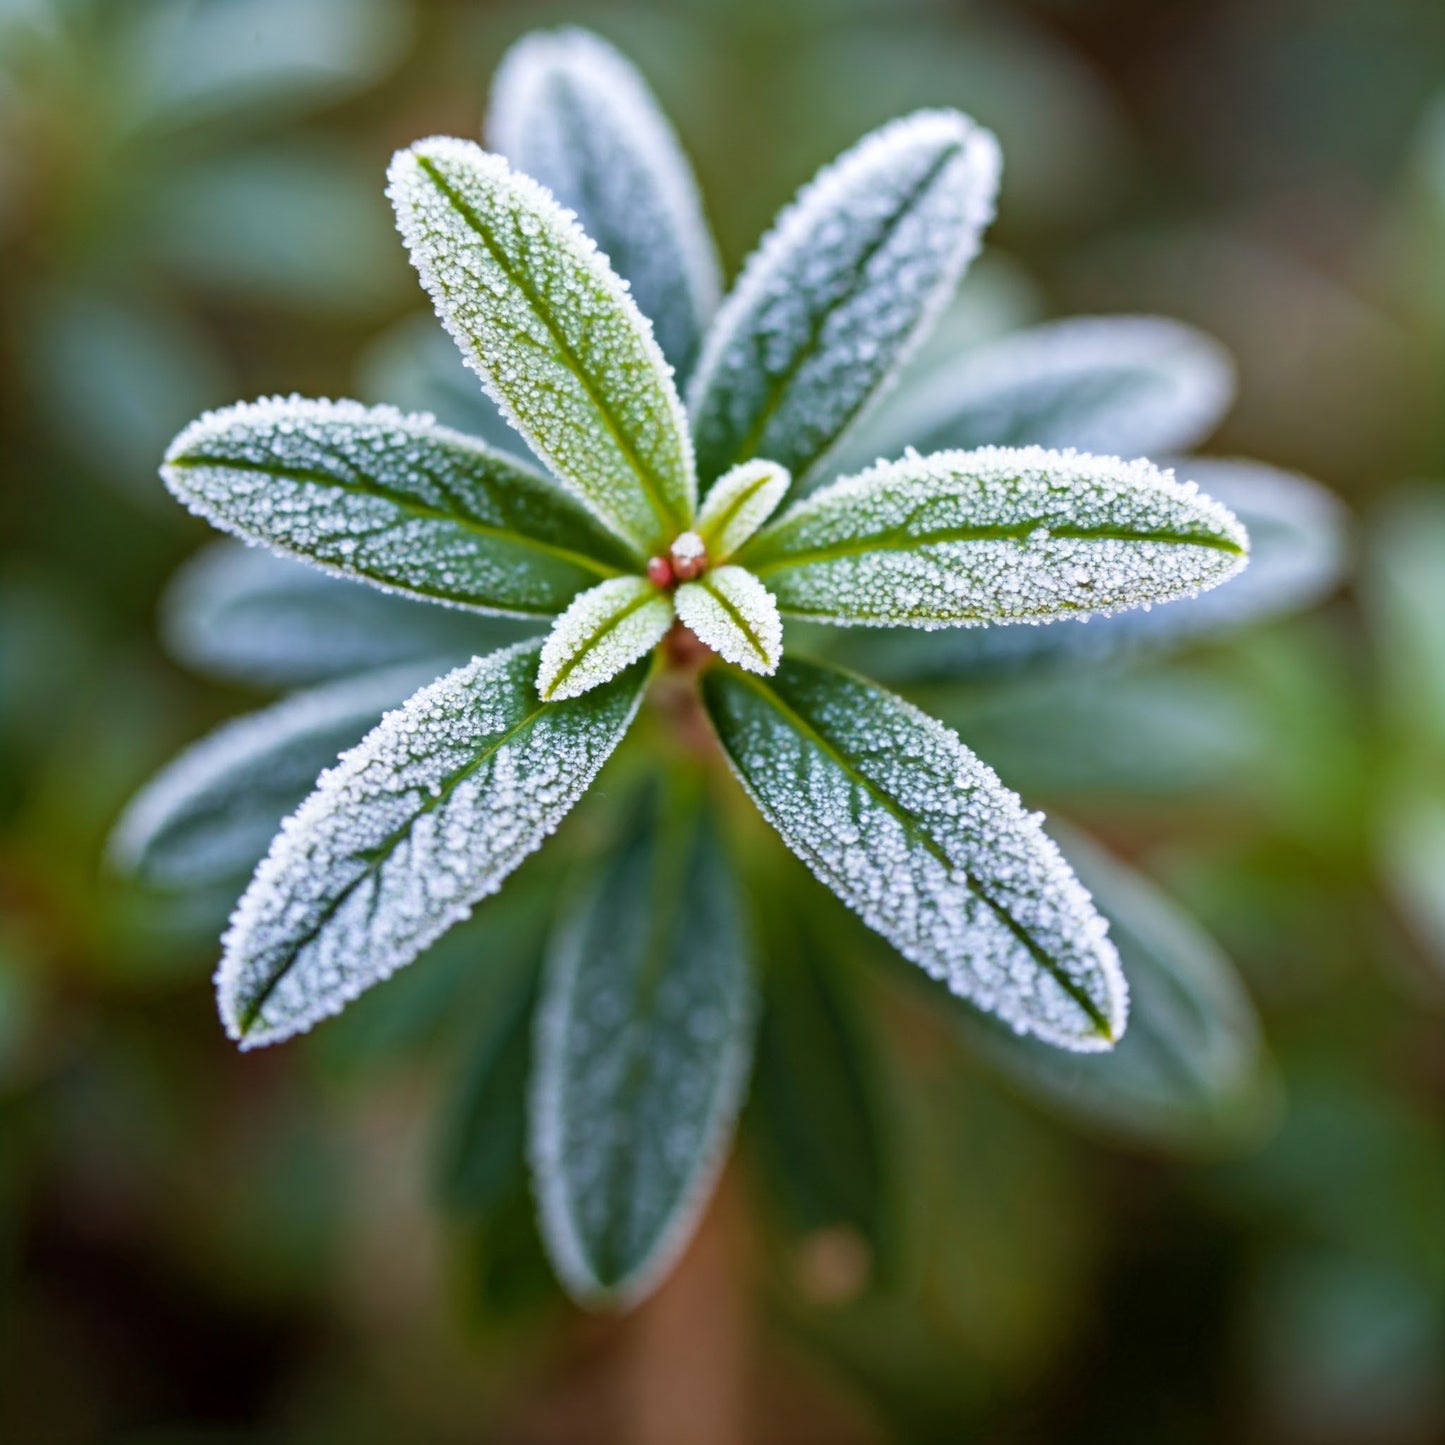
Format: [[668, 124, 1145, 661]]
[[959, 829, 1270, 1147]]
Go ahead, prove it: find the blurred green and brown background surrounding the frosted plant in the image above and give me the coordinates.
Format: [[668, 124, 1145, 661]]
[[0, 0, 1445, 1445]]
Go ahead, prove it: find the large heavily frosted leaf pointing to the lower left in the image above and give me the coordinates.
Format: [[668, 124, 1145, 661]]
[[215, 643, 646, 1048]]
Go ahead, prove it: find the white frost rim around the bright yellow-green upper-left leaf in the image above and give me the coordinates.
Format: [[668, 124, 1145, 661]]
[[386, 136, 698, 549]]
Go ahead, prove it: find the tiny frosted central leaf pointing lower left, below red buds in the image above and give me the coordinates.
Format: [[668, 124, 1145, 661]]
[[538, 577, 672, 702]]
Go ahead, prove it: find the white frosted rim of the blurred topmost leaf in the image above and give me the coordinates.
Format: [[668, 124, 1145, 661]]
[[484, 26, 723, 331]]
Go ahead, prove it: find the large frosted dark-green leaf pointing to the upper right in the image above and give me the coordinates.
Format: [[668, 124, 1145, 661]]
[[688, 110, 1000, 481]]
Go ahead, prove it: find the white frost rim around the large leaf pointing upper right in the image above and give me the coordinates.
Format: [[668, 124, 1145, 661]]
[[688, 108, 1003, 481]]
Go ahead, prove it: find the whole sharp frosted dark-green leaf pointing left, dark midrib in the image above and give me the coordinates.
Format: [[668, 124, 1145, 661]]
[[160, 396, 630, 617]]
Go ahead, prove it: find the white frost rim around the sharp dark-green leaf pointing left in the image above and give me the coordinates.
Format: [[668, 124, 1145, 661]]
[[160, 392, 586, 621]]
